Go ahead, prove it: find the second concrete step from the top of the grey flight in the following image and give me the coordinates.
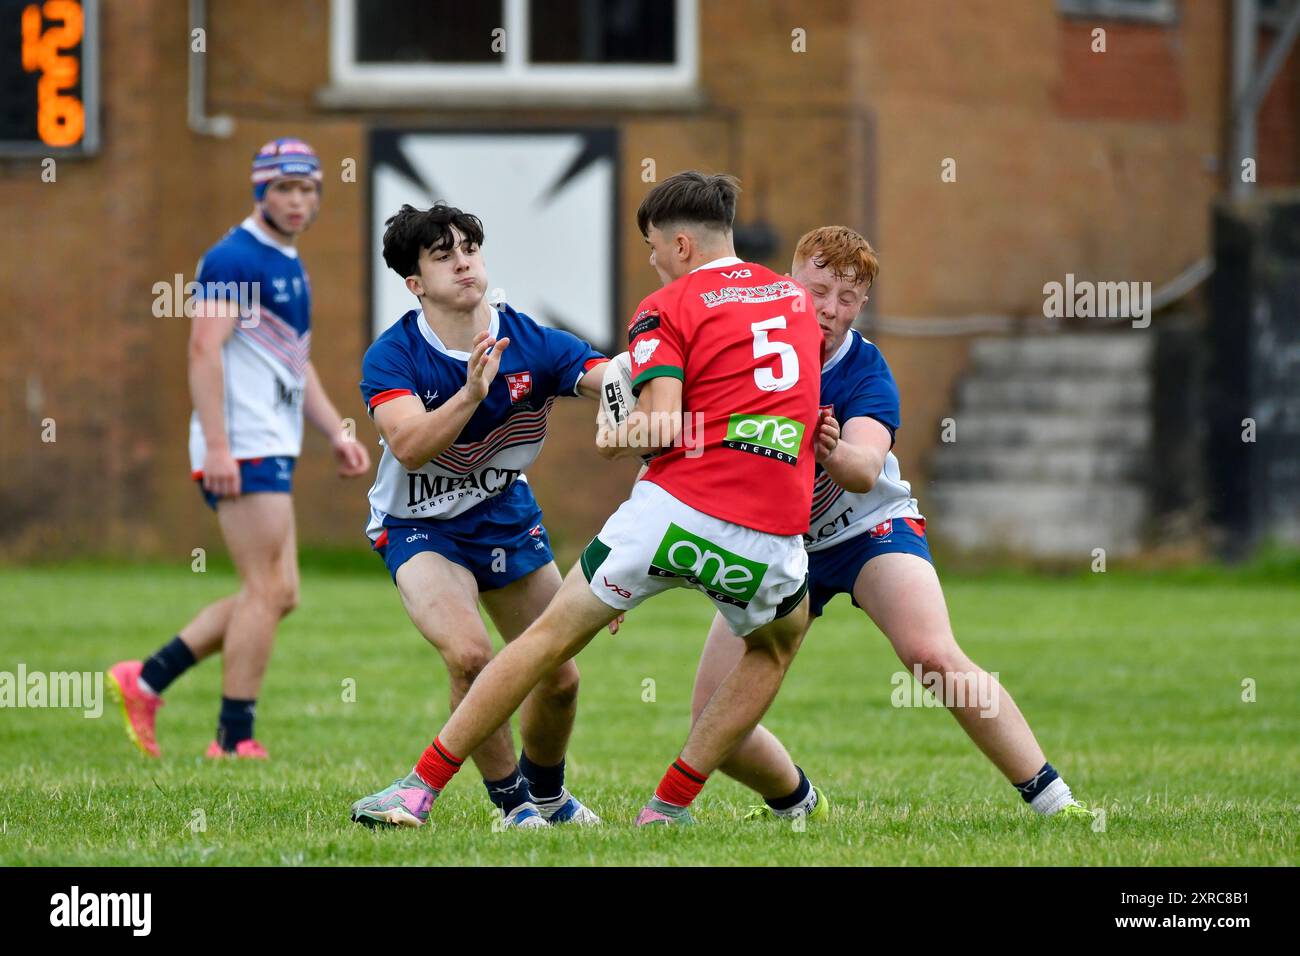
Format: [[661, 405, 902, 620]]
[[957, 372, 1151, 415]]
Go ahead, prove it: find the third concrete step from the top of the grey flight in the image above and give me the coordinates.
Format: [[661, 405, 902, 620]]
[[935, 410, 1152, 444]]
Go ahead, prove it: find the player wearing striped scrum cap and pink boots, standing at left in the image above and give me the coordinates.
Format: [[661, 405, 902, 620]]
[[108, 138, 371, 757]]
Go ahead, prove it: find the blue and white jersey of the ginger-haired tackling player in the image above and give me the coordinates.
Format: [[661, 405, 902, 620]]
[[803, 329, 920, 551]]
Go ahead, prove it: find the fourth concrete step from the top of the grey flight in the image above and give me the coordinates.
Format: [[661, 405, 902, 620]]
[[930, 442, 1149, 483]]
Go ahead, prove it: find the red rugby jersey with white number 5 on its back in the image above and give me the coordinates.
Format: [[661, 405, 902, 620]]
[[628, 258, 822, 535]]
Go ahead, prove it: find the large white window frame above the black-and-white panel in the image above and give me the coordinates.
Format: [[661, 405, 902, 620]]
[[321, 0, 699, 107]]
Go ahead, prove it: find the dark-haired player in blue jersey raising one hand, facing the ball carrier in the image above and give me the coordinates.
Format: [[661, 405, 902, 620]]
[[352, 203, 616, 829]]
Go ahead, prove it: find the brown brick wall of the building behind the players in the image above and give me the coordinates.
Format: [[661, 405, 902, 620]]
[[0, 0, 1297, 561]]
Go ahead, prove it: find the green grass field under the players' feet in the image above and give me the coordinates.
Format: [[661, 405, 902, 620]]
[[0, 555, 1300, 866]]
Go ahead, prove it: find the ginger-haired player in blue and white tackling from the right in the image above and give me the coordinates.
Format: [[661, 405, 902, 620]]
[[692, 226, 1091, 819]]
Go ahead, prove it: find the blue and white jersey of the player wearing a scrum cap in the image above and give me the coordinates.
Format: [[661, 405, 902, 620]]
[[190, 216, 312, 476]]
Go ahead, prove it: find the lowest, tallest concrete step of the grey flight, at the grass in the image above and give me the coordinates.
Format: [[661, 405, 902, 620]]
[[922, 481, 1147, 562]]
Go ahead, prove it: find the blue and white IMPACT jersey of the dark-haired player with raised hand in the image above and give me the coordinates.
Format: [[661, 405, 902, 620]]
[[361, 303, 606, 541]]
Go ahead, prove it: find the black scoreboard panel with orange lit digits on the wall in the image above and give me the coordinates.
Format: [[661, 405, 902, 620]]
[[0, 0, 99, 156]]
